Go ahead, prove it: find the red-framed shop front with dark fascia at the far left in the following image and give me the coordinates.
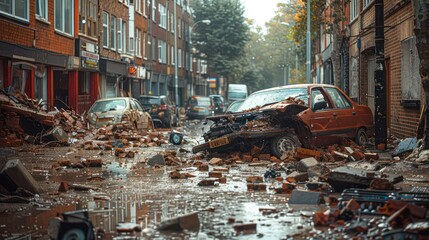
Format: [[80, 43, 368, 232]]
[[0, 41, 69, 109]]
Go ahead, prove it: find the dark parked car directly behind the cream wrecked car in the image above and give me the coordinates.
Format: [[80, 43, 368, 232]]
[[139, 95, 178, 128]]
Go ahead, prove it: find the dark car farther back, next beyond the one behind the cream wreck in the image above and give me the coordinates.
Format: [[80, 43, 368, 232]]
[[186, 96, 214, 119]]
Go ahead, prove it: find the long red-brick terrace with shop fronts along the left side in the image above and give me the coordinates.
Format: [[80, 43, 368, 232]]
[[0, 0, 206, 113]]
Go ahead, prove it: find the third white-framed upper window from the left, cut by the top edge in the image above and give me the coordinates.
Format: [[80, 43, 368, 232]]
[[55, 0, 74, 35]]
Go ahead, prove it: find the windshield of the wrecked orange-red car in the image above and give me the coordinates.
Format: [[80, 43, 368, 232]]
[[237, 87, 308, 112]]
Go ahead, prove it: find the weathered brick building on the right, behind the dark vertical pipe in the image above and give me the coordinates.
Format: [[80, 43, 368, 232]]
[[318, 0, 422, 138]]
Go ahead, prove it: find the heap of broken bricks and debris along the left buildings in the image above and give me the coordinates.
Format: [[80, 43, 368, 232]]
[[0, 91, 171, 149]]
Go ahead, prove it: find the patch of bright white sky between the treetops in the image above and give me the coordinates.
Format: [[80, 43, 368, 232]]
[[241, 0, 284, 27]]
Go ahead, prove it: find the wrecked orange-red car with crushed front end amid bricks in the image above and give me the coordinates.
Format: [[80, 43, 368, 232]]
[[192, 84, 374, 157]]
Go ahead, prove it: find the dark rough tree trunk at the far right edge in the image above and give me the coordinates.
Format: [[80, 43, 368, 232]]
[[413, 0, 429, 149]]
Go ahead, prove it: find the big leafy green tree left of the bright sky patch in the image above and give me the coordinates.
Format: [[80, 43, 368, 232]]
[[191, 0, 249, 79]]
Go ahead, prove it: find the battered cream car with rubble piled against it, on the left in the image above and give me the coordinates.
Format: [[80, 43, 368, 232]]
[[86, 97, 153, 130]]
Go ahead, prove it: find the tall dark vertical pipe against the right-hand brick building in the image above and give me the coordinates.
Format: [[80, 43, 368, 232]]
[[374, 0, 387, 150]]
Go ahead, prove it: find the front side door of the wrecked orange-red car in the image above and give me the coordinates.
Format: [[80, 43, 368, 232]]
[[308, 87, 338, 146]]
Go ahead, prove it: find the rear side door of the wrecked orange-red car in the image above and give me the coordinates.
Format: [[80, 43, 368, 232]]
[[324, 87, 359, 137]]
